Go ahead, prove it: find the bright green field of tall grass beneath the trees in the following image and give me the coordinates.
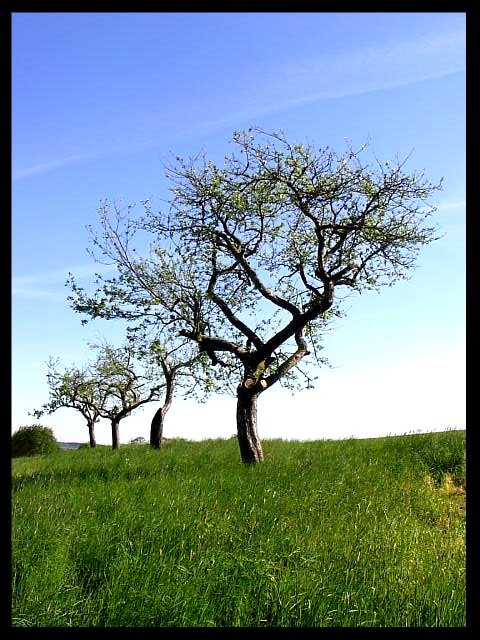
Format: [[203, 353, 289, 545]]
[[12, 431, 466, 627]]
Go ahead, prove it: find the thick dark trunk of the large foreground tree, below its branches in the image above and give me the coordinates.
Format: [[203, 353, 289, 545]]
[[237, 385, 263, 464]]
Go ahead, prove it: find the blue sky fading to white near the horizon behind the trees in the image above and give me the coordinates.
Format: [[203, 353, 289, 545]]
[[12, 12, 466, 443]]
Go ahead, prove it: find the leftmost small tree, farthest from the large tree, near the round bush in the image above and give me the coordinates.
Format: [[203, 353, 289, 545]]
[[32, 358, 107, 447]]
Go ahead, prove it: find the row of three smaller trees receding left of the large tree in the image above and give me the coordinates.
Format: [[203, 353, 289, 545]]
[[32, 335, 208, 449]]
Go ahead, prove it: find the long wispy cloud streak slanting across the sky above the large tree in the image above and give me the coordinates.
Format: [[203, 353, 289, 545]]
[[13, 29, 466, 181]]
